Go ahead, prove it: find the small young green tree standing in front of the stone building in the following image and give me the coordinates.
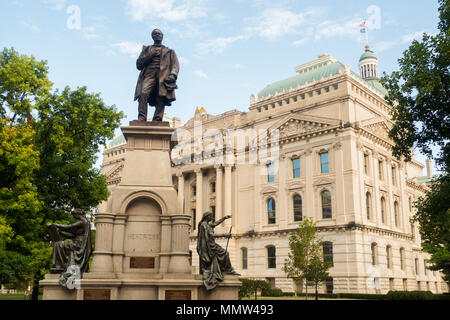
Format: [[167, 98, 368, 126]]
[[283, 218, 331, 300]]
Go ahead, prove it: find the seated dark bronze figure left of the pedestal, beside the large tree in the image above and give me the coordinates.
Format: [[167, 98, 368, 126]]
[[47, 209, 93, 289]]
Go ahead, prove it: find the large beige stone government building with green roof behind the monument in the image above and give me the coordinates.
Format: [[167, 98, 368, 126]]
[[99, 46, 448, 293]]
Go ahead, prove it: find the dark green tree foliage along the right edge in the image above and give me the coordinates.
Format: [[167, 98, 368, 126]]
[[382, 0, 450, 281]]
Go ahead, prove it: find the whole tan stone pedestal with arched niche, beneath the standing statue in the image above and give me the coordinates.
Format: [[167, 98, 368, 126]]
[[40, 121, 240, 300]]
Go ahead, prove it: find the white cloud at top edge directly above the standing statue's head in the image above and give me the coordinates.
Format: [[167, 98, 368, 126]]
[[126, 0, 208, 21]]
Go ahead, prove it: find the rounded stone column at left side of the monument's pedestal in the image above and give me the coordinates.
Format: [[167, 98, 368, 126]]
[[85, 213, 114, 278]]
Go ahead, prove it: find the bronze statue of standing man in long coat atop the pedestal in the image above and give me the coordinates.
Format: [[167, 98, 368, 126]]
[[134, 29, 180, 121]]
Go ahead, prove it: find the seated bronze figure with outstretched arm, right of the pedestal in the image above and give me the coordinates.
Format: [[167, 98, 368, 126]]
[[197, 211, 239, 291]]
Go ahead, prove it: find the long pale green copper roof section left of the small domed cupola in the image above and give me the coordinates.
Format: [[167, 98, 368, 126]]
[[258, 62, 344, 99]]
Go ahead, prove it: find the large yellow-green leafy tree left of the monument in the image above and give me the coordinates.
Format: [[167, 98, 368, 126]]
[[0, 49, 123, 298]]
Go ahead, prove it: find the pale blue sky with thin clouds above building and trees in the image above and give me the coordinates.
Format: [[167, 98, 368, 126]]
[[0, 0, 438, 174]]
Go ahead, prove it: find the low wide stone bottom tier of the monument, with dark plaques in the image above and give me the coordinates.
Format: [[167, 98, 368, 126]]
[[40, 274, 241, 300]]
